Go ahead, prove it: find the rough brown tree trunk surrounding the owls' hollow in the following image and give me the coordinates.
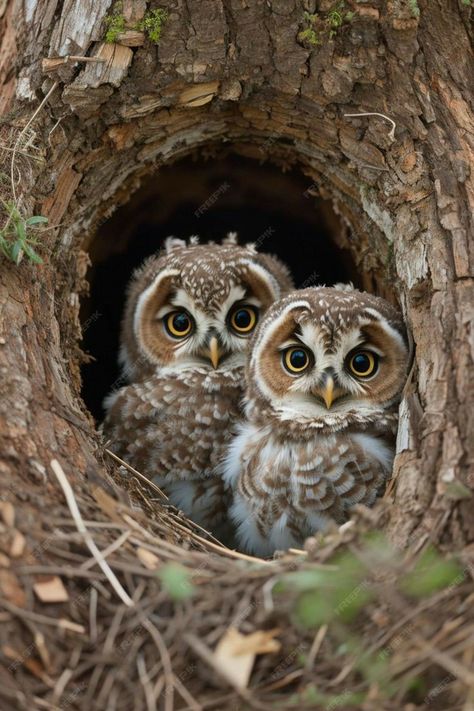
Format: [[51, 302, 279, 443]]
[[0, 0, 474, 708]]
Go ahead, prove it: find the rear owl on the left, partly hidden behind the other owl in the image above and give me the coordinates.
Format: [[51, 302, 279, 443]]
[[104, 234, 292, 535]]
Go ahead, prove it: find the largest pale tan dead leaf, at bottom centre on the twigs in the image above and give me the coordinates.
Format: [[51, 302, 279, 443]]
[[213, 627, 281, 689]]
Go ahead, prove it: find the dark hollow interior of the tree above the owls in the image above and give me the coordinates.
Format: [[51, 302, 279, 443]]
[[81, 155, 359, 422]]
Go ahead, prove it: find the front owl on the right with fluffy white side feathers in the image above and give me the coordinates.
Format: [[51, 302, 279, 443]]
[[223, 286, 408, 556]]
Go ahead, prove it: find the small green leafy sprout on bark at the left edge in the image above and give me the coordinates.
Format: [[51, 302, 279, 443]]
[[0, 202, 48, 264]]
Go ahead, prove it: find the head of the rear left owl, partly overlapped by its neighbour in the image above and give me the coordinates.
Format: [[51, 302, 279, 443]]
[[120, 233, 292, 380]]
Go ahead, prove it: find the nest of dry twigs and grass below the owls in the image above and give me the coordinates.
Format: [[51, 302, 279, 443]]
[[0, 444, 474, 711]]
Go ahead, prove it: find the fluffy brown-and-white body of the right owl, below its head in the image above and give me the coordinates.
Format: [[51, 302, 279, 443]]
[[223, 424, 393, 555]]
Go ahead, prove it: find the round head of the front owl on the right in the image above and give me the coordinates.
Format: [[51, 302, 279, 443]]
[[247, 286, 408, 432]]
